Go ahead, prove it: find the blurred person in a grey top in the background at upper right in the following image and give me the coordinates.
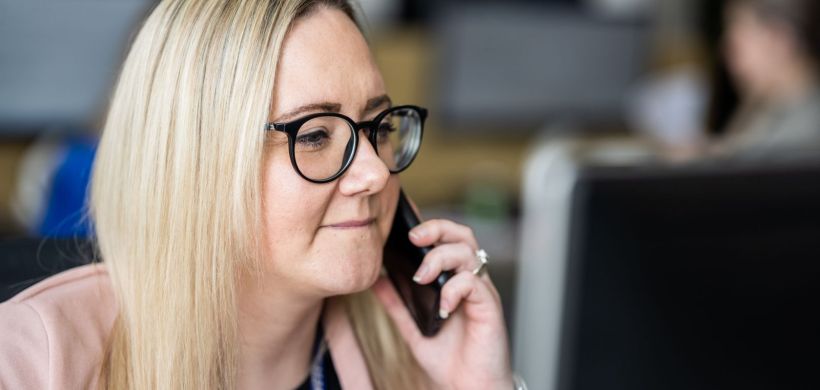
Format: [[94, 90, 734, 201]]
[[710, 0, 820, 160]]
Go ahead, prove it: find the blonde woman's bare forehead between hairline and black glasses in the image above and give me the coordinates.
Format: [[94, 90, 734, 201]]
[[271, 8, 385, 118]]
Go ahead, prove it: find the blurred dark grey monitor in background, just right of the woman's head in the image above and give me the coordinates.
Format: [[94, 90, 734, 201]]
[[431, 2, 651, 132]]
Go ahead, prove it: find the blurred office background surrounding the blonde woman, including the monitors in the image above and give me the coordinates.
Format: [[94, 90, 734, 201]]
[[0, 0, 820, 389]]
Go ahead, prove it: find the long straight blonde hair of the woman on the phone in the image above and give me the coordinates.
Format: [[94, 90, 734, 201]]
[[91, 0, 425, 389]]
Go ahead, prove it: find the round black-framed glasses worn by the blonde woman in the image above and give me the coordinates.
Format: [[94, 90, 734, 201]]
[[265, 105, 427, 183]]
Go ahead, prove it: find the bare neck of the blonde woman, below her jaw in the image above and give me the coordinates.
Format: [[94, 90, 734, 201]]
[[237, 276, 324, 389]]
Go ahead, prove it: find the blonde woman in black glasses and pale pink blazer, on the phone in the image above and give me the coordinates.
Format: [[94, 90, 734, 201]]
[[0, 0, 514, 389]]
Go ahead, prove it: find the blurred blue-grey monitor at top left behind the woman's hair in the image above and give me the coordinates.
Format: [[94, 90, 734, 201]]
[[0, 0, 151, 136]]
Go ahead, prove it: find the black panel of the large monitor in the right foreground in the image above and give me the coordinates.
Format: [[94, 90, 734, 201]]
[[559, 163, 820, 390]]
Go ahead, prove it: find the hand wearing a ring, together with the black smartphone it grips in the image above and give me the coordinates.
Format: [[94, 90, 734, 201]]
[[373, 189, 513, 389]]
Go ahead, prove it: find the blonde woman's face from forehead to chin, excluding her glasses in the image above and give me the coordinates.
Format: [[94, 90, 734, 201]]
[[262, 8, 399, 296]]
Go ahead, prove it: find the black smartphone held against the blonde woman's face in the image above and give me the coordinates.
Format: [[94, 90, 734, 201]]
[[384, 190, 453, 337]]
